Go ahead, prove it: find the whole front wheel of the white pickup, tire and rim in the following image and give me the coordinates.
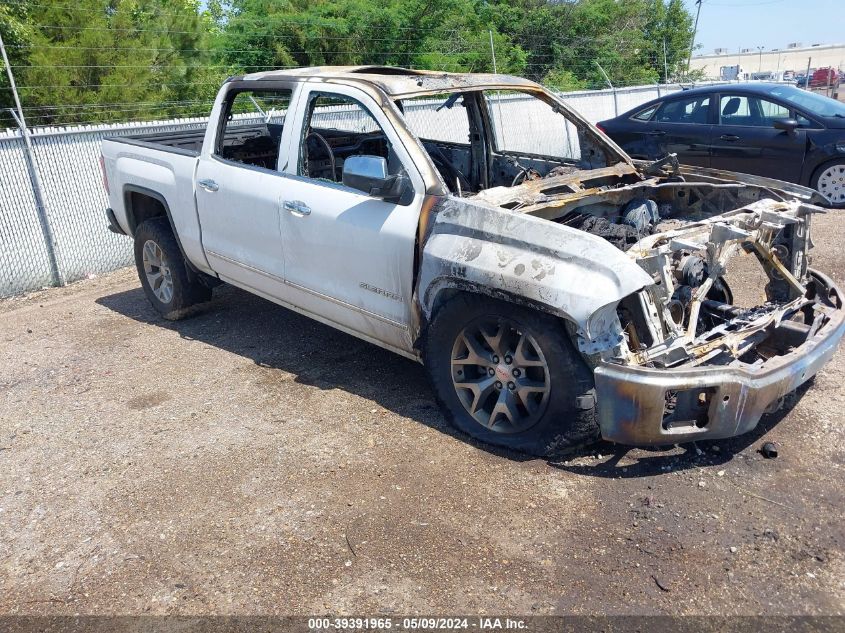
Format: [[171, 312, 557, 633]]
[[423, 294, 599, 456]]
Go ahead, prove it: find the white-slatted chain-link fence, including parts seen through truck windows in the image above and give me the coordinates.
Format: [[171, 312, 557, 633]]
[[0, 86, 712, 297]]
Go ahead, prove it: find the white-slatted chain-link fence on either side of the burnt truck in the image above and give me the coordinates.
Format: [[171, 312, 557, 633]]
[[0, 85, 680, 297]]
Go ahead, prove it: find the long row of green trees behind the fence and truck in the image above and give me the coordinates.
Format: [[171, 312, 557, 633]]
[[0, 0, 692, 124]]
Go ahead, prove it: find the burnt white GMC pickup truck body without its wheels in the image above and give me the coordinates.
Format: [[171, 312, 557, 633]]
[[102, 67, 845, 444]]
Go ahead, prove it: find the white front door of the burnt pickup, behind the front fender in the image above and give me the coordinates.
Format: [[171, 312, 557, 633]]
[[281, 85, 424, 351]]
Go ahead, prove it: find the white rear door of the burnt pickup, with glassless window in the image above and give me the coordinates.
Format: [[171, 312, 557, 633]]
[[196, 85, 300, 297]]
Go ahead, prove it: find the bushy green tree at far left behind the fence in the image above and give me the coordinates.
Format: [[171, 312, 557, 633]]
[[5, 0, 214, 125]]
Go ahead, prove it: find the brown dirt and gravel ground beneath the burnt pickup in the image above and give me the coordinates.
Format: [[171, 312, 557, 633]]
[[0, 212, 845, 615]]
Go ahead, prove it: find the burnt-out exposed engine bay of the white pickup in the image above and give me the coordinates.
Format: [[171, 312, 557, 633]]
[[476, 158, 839, 378]]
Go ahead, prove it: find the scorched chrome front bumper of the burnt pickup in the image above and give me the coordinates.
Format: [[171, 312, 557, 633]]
[[595, 271, 845, 446]]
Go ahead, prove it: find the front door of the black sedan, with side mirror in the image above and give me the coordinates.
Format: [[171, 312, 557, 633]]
[[711, 92, 807, 182]]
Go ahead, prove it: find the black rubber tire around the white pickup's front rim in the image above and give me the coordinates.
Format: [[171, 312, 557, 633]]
[[423, 294, 599, 457]]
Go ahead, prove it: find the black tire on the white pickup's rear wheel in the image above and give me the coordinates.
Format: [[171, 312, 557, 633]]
[[135, 218, 211, 321]]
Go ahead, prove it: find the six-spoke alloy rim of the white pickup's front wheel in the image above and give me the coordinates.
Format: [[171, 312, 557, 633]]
[[451, 318, 550, 434]]
